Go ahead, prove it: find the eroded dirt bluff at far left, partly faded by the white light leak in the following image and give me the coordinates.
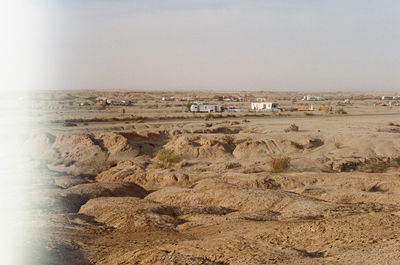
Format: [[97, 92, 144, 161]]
[[37, 132, 168, 176]]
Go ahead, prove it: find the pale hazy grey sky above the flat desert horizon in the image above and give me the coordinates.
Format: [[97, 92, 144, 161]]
[[3, 0, 400, 91]]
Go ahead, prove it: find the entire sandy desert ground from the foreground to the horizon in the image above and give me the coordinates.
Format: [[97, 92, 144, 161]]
[[21, 91, 400, 265]]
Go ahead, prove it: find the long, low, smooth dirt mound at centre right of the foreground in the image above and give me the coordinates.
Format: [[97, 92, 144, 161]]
[[146, 179, 331, 216]]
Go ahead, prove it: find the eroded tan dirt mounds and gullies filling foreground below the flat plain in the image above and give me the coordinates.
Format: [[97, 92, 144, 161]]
[[32, 124, 400, 264]]
